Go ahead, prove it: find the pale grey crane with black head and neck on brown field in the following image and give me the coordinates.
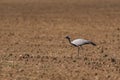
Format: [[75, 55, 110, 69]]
[[65, 36, 96, 56]]
